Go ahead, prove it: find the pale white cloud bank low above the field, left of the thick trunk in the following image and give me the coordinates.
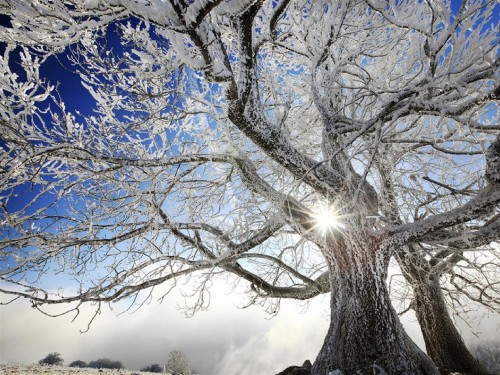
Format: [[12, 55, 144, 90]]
[[0, 287, 328, 374]]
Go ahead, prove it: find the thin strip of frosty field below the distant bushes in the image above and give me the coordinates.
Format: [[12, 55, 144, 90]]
[[0, 365, 159, 375]]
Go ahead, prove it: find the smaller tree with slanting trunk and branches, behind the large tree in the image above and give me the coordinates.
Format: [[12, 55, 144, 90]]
[[381, 142, 500, 374]]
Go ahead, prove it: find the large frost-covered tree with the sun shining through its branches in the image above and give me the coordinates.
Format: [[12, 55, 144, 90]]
[[0, 0, 500, 374]]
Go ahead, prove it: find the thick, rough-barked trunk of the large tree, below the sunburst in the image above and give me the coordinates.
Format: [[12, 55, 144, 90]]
[[312, 233, 438, 375]]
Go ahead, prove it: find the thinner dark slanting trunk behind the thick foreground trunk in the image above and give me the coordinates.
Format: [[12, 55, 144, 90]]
[[413, 277, 488, 375]]
